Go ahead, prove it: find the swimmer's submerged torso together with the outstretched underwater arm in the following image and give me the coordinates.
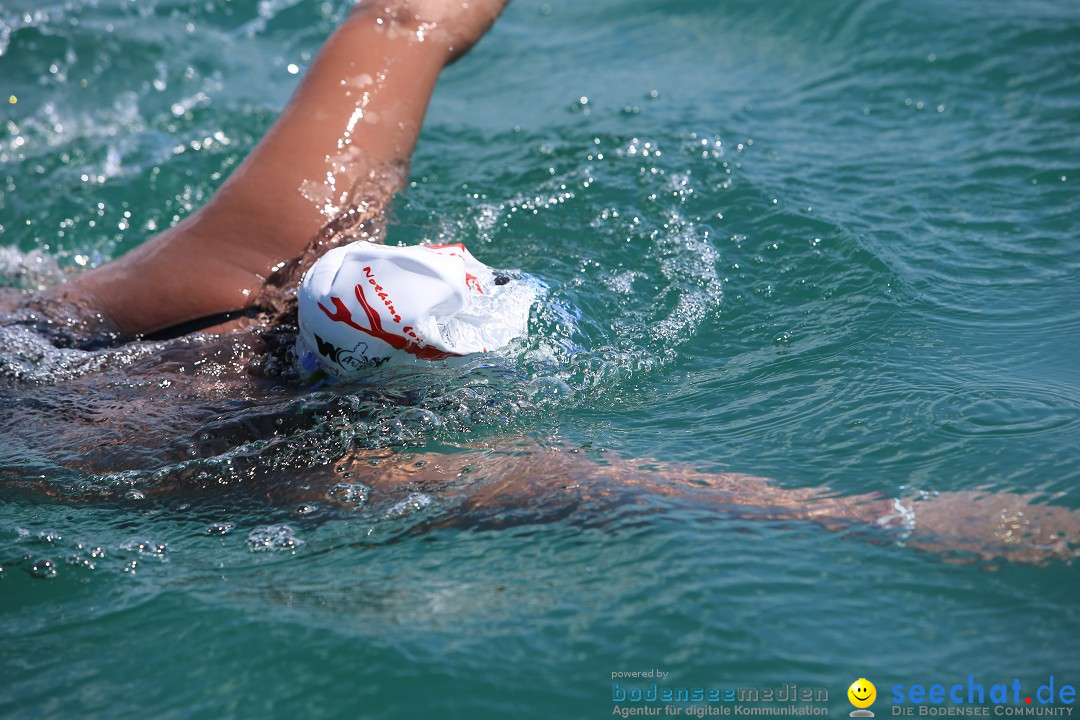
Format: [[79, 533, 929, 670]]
[[0, 266, 1080, 562]]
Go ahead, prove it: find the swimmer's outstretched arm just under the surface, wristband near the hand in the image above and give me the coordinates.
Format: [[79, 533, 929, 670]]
[[328, 441, 1080, 562]]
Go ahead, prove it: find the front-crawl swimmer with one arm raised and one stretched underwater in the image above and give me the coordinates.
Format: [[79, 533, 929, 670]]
[[0, 0, 1080, 562]]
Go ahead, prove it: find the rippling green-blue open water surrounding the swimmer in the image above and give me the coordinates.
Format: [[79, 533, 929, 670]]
[[0, 0, 1080, 718]]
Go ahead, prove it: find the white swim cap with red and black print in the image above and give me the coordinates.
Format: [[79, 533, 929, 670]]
[[297, 241, 536, 380]]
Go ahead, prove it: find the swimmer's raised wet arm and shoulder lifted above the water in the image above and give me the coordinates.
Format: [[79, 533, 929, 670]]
[[51, 0, 507, 334]]
